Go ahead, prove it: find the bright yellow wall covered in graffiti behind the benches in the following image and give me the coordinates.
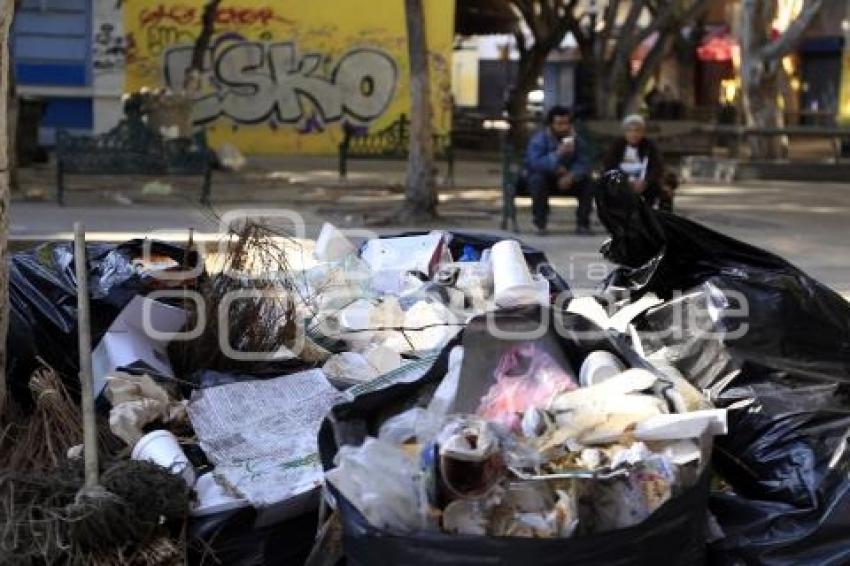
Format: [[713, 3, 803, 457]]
[[122, 0, 455, 154]]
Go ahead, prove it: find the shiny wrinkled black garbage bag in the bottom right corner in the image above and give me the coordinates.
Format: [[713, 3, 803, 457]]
[[710, 368, 850, 564]]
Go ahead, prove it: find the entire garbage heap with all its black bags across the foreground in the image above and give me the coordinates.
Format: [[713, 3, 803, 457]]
[[0, 174, 850, 566]]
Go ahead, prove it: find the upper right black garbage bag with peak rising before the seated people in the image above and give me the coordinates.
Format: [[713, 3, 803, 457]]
[[596, 172, 850, 382]]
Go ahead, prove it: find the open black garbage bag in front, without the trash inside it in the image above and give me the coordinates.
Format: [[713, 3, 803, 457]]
[[319, 307, 709, 566]]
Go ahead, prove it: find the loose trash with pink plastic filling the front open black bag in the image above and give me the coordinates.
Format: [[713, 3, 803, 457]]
[[327, 336, 726, 538]]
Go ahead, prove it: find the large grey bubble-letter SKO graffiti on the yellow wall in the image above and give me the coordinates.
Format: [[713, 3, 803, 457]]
[[163, 41, 398, 128]]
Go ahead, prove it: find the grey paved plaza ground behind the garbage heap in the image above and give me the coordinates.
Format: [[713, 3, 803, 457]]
[[11, 158, 850, 296]]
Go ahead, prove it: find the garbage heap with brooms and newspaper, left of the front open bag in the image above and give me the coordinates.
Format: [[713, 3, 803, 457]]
[[0, 223, 565, 564]]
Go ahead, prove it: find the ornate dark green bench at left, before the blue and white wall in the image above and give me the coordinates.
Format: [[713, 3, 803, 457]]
[[56, 114, 213, 205]]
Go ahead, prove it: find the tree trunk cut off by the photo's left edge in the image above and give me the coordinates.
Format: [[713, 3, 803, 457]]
[[0, 0, 15, 417]]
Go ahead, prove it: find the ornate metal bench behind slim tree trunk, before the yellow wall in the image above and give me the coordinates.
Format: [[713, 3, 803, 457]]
[[339, 114, 454, 185]]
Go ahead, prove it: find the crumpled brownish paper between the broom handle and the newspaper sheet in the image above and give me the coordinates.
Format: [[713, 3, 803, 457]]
[[106, 372, 188, 446]]
